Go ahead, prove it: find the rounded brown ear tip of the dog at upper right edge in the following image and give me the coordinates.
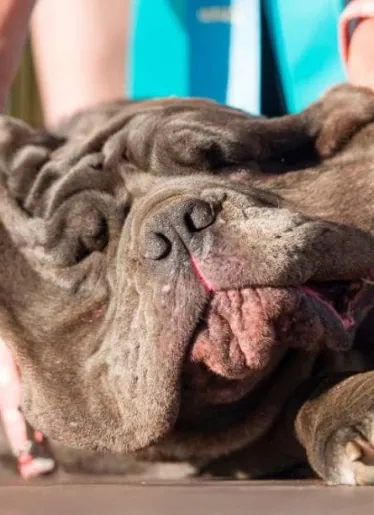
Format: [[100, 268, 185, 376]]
[[306, 84, 374, 159]]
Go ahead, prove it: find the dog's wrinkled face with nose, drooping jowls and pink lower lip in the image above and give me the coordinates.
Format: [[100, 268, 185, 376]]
[[0, 90, 374, 462]]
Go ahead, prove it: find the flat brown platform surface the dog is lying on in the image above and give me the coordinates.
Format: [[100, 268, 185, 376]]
[[0, 477, 374, 515]]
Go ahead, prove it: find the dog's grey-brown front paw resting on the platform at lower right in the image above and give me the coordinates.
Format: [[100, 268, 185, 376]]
[[295, 371, 374, 485]]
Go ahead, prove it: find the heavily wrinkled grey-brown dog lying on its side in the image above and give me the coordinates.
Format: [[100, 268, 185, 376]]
[[0, 85, 374, 485]]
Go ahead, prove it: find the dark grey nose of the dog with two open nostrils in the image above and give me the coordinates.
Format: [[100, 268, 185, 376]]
[[141, 199, 217, 261]]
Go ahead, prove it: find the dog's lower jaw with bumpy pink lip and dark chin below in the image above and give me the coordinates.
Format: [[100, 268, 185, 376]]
[[182, 283, 359, 407]]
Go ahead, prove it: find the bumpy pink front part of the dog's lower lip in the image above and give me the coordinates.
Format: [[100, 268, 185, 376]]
[[191, 288, 294, 379]]
